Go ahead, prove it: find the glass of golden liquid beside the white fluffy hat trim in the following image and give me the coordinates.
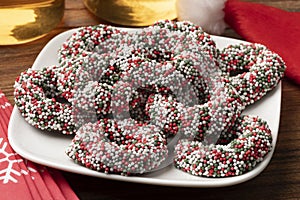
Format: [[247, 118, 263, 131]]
[[83, 0, 176, 26]]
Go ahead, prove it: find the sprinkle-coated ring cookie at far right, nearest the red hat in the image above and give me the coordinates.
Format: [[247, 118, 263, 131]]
[[219, 43, 286, 105]]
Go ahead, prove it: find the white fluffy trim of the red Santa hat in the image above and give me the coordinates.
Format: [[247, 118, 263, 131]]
[[176, 0, 226, 35]]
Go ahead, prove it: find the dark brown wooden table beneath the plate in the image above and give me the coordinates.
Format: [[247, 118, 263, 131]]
[[0, 0, 300, 199]]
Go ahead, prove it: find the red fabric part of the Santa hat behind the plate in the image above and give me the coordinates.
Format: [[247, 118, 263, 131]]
[[224, 0, 300, 84]]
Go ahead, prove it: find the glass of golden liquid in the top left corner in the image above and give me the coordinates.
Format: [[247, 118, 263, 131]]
[[0, 0, 65, 45]]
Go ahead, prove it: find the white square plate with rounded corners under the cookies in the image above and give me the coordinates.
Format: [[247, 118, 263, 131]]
[[8, 30, 281, 187]]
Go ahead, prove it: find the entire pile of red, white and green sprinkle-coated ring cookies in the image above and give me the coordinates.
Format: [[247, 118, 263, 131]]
[[14, 20, 285, 177]]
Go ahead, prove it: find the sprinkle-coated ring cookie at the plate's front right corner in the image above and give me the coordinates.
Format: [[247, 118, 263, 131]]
[[174, 115, 272, 177]]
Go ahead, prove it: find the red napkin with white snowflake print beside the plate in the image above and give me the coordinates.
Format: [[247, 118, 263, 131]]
[[0, 90, 78, 200]]
